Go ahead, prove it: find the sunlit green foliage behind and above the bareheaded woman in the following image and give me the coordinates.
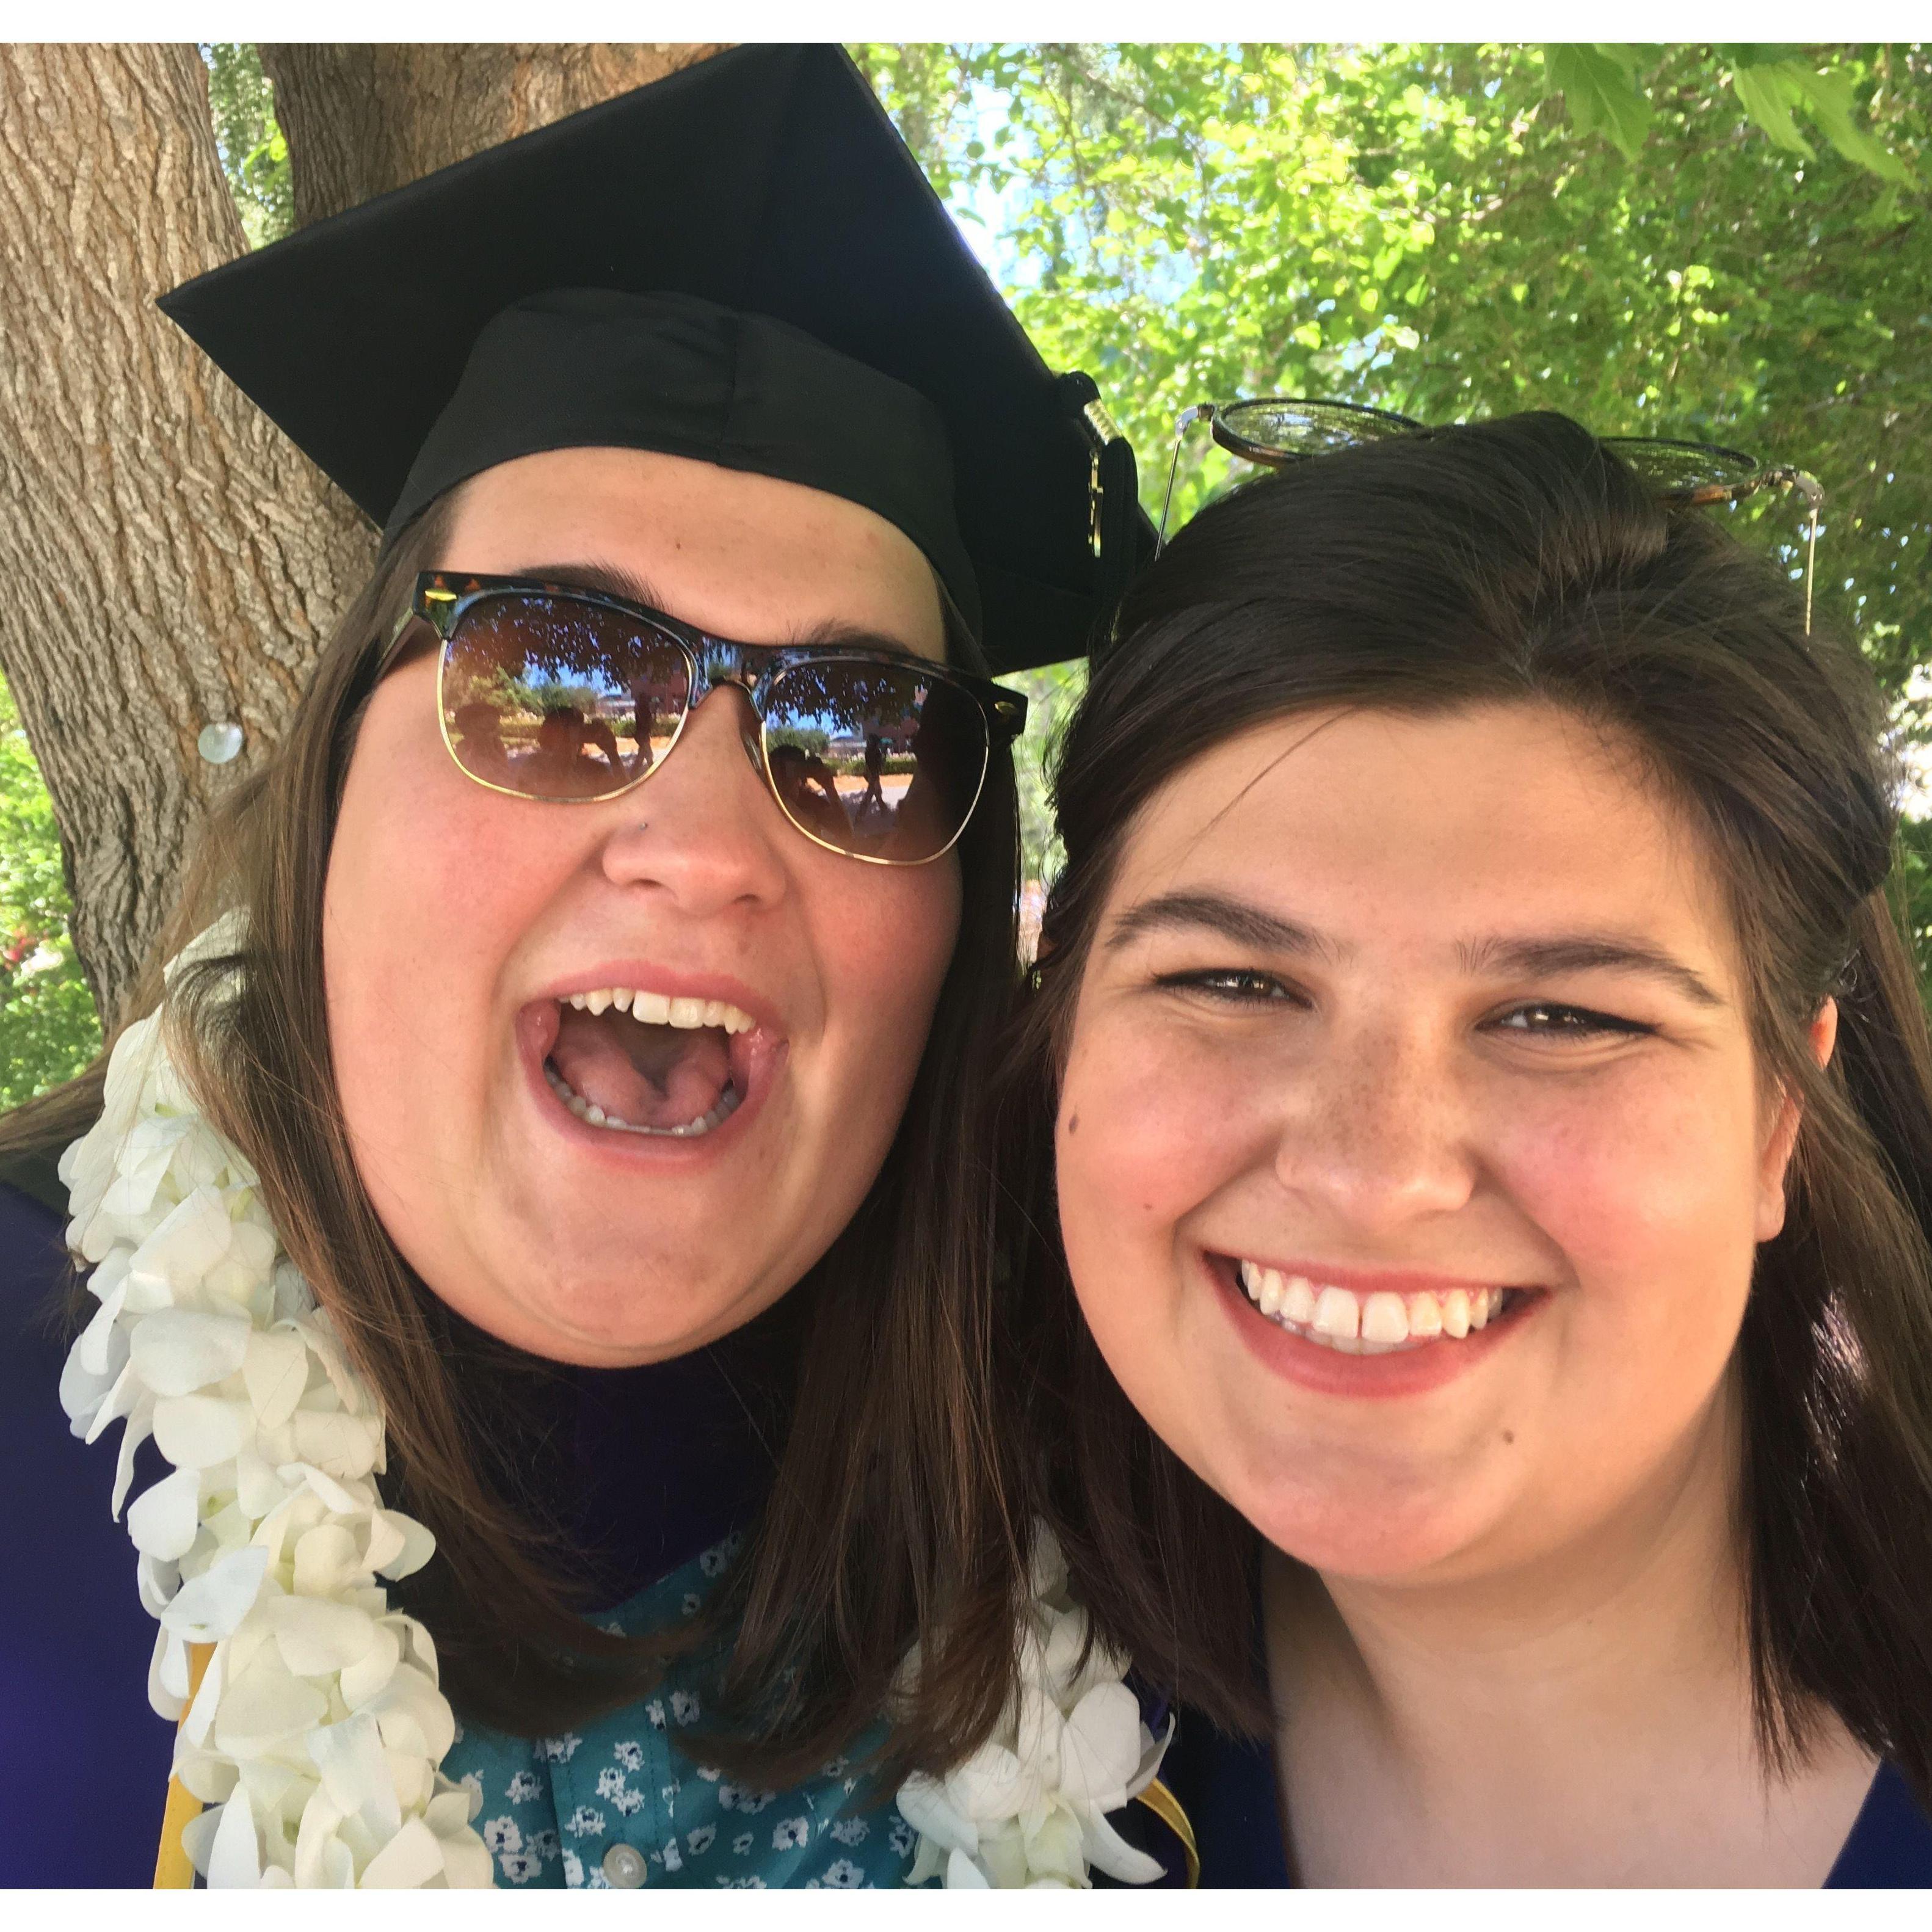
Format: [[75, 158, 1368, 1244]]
[[854, 43, 1932, 981]]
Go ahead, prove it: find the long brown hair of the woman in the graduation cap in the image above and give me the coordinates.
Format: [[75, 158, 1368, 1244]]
[[0, 487, 1020, 1783]]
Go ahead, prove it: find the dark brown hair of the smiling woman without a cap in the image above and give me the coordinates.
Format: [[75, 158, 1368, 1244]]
[[999, 415, 1932, 1799]]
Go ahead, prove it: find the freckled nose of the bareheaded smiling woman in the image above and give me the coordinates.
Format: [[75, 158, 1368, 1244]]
[[1275, 1018, 1480, 1235]]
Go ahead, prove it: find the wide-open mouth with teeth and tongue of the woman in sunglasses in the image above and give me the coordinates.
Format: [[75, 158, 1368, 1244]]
[[543, 986, 757, 1140]]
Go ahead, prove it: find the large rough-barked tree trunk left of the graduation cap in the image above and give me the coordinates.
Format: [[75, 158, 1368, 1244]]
[[0, 45, 373, 1026]]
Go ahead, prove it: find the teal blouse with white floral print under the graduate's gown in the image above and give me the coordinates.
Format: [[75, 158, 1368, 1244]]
[[443, 1536, 916, 1892]]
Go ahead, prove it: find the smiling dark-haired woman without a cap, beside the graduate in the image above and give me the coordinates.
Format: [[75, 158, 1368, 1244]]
[[1009, 415, 1932, 1886]]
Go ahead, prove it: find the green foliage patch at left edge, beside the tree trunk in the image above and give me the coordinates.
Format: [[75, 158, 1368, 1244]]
[[0, 682, 101, 1113]]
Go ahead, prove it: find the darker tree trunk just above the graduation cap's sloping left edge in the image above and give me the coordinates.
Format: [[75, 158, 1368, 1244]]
[[261, 43, 719, 226]]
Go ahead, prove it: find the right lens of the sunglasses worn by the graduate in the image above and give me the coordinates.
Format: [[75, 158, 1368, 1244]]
[[765, 659, 987, 865]]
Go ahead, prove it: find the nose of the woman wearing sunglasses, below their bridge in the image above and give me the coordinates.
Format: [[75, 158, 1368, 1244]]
[[603, 684, 798, 918]]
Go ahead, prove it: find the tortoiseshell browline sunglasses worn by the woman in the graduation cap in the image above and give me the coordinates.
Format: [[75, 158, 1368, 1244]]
[[379, 570, 1026, 865]]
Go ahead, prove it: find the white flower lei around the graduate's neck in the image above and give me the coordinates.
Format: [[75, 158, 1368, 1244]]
[[60, 916, 1171, 1889]]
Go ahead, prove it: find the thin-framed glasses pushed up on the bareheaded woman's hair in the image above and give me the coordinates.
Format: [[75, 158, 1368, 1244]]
[[1159, 396, 1824, 636]]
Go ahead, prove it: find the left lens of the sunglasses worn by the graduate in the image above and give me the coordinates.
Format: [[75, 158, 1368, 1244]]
[[440, 591, 692, 798]]
